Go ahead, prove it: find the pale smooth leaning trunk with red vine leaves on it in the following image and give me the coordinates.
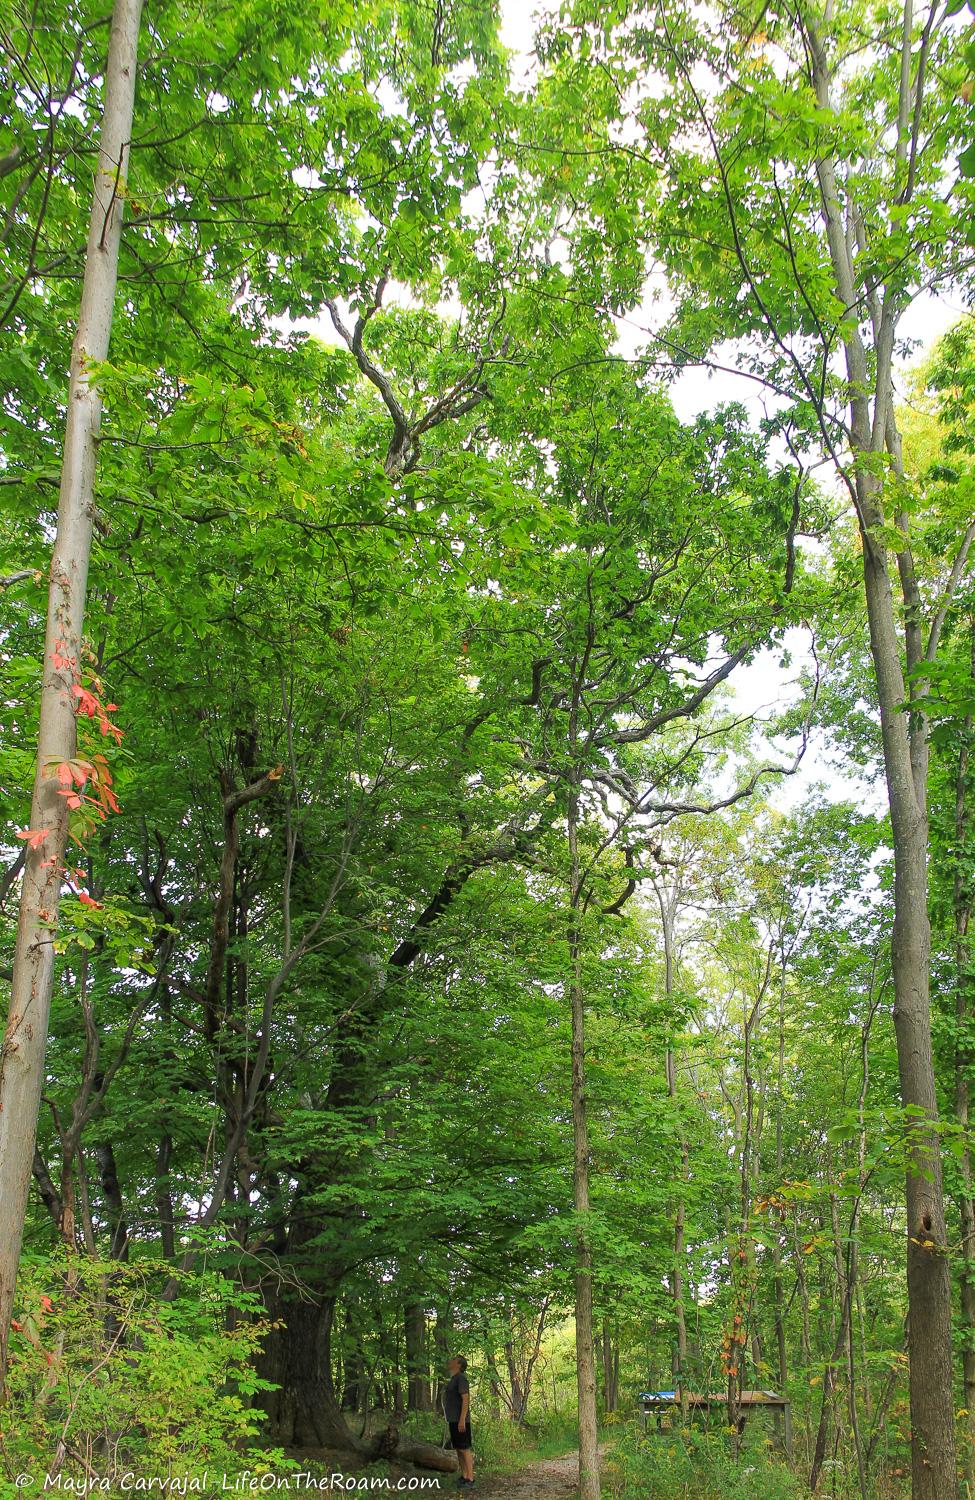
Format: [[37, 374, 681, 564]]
[[0, 0, 143, 1389]]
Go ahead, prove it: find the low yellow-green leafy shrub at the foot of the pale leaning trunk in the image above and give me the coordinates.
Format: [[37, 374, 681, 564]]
[[0, 1259, 281, 1488]]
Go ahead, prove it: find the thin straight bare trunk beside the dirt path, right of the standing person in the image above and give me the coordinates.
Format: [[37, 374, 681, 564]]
[[569, 782, 600, 1500]]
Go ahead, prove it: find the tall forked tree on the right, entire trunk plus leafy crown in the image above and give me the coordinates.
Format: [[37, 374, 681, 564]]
[[561, 0, 974, 1500]]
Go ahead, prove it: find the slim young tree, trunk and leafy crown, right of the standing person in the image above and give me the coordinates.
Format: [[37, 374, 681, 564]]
[[498, 357, 800, 1500]]
